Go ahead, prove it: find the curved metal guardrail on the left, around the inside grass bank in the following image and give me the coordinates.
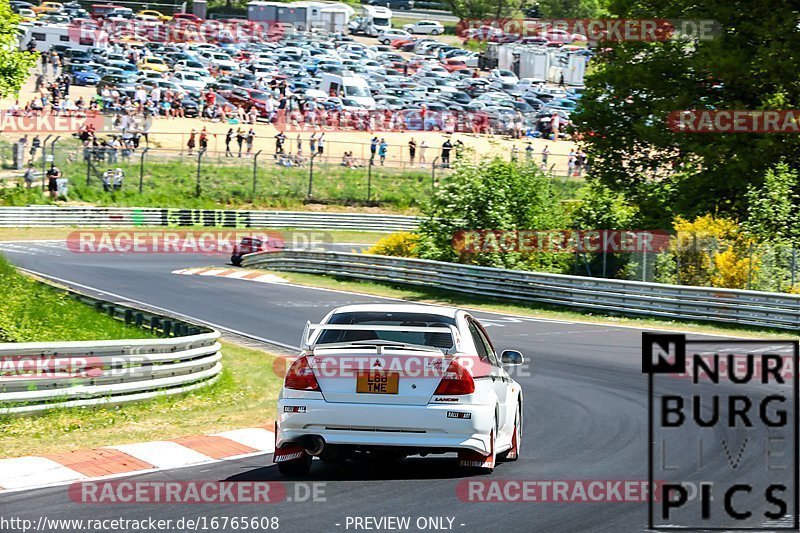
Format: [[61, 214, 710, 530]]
[[0, 280, 222, 415]]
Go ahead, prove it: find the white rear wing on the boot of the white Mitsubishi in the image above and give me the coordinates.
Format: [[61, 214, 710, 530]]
[[300, 321, 463, 355]]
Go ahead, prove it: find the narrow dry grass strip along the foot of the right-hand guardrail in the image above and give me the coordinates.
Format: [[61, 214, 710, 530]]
[[258, 271, 790, 338]]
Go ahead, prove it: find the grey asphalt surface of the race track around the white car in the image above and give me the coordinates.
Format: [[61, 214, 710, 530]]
[[0, 243, 796, 532]]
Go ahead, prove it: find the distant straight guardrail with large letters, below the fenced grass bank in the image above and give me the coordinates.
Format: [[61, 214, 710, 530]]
[[0, 205, 420, 233]]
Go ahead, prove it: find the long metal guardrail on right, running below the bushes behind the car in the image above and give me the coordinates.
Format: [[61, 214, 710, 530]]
[[242, 251, 800, 330]]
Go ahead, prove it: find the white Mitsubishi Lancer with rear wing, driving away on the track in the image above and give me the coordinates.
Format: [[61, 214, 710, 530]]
[[274, 304, 523, 475]]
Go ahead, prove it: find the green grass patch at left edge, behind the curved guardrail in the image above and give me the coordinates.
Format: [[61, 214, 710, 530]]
[[0, 257, 152, 342]]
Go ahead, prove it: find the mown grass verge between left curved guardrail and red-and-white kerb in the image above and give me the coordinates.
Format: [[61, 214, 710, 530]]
[[0, 342, 282, 458]]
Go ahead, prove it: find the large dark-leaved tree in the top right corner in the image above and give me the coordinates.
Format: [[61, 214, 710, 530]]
[[574, 0, 800, 227]]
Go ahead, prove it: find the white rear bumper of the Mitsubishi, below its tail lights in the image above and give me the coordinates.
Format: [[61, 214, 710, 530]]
[[275, 398, 494, 454]]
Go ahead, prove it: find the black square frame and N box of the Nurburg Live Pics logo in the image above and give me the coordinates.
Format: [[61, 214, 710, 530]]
[[642, 332, 800, 531]]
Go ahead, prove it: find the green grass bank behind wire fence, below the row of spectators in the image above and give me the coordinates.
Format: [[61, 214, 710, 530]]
[[0, 153, 446, 212]]
